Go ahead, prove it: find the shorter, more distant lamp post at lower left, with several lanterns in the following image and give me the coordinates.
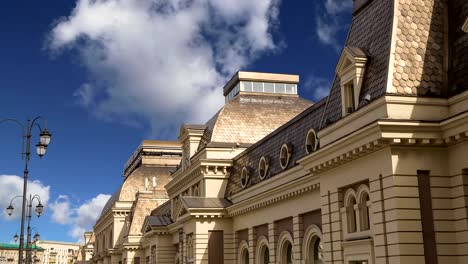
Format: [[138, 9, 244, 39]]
[[6, 194, 44, 264]]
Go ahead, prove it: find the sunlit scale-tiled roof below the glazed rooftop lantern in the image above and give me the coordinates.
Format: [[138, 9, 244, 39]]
[[198, 95, 312, 150]]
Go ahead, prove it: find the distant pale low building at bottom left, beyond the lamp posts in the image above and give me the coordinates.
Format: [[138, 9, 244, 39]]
[[37, 240, 81, 264]]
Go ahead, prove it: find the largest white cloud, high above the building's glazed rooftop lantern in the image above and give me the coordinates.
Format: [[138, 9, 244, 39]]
[[47, 0, 279, 135]]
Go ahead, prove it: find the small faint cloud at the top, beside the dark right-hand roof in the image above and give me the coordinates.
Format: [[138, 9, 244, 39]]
[[315, 0, 353, 51]]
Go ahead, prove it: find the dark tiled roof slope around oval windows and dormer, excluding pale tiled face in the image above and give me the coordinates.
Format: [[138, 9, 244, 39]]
[[226, 0, 393, 196]]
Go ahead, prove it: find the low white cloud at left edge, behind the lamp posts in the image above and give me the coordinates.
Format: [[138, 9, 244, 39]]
[[0, 175, 50, 220]]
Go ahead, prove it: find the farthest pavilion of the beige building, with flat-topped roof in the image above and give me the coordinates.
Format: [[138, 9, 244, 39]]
[[89, 140, 182, 264]]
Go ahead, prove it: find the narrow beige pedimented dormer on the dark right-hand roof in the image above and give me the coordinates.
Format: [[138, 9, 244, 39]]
[[336, 47, 367, 116]]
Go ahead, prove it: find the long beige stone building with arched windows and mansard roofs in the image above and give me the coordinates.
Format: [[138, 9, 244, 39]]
[[88, 0, 468, 264]]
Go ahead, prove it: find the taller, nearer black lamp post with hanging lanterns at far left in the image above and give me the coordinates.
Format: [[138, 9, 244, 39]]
[[0, 116, 52, 264]]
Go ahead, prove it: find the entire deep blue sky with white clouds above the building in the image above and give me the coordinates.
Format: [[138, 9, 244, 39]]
[[0, 0, 352, 242]]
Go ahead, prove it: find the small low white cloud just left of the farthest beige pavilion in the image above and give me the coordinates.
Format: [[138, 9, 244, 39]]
[[51, 194, 110, 241]]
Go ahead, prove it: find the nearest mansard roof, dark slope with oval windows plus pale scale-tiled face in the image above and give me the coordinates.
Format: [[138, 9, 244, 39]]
[[226, 0, 468, 196]]
